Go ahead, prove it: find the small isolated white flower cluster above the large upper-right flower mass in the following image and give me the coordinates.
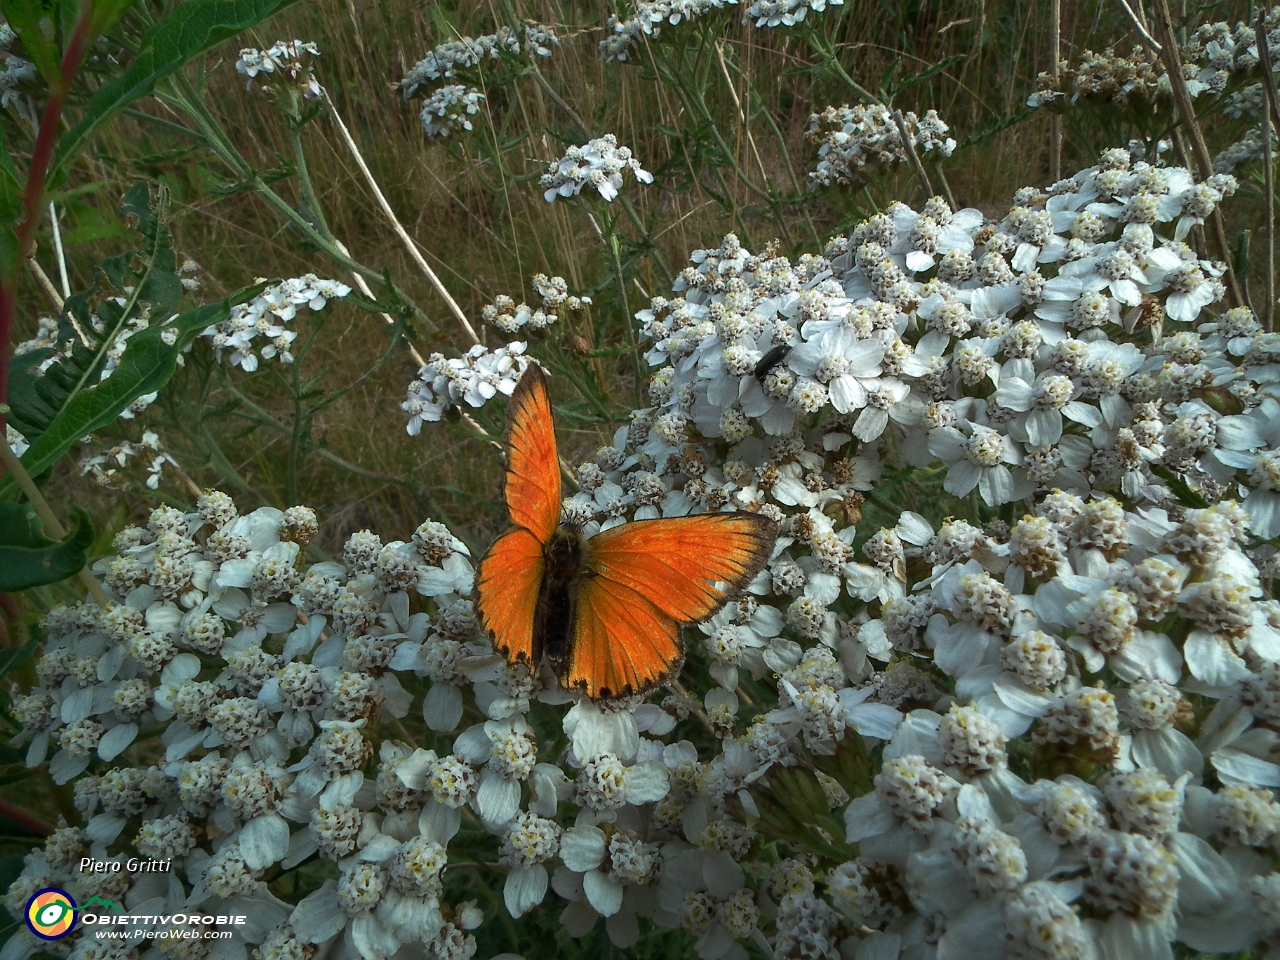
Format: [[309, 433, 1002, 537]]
[[805, 104, 956, 187]]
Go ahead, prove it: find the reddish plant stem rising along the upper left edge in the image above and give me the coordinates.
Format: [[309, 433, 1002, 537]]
[[0, 0, 93, 430]]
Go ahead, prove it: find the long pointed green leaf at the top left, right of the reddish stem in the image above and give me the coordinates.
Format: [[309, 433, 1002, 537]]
[[49, 0, 304, 183]]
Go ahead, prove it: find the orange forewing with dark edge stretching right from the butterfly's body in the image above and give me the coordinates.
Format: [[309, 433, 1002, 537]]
[[589, 513, 777, 623]]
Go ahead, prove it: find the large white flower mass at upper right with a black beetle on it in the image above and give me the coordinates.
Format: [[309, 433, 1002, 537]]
[[640, 150, 1259, 519]]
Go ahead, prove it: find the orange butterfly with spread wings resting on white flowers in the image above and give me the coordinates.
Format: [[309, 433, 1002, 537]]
[[476, 364, 777, 700]]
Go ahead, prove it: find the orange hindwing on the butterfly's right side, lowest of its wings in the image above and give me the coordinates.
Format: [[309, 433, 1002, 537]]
[[561, 576, 682, 700]]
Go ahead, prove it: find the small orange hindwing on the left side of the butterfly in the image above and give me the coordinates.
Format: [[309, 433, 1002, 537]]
[[476, 526, 547, 669]]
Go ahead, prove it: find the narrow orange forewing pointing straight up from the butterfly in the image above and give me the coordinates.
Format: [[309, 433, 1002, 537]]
[[504, 364, 561, 544]]
